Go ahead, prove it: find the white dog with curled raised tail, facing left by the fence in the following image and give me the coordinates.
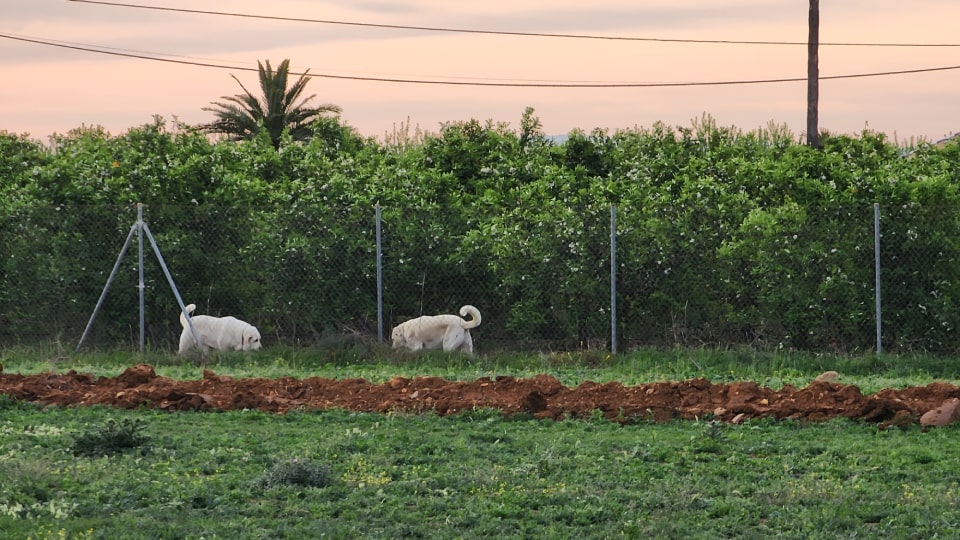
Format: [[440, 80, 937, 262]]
[[391, 306, 480, 355]]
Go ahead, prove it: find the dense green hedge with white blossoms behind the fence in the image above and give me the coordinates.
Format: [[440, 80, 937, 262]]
[[0, 115, 960, 354]]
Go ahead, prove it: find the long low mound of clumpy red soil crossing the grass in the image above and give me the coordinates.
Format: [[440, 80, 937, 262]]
[[0, 364, 960, 427]]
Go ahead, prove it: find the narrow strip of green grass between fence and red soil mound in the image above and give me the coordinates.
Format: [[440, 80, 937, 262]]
[[0, 345, 960, 394]]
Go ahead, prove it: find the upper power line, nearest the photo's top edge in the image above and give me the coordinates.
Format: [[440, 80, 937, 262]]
[[69, 0, 960, 47]]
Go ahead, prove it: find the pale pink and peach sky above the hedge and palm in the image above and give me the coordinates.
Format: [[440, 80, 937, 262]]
[[0, 0, 960, 141]]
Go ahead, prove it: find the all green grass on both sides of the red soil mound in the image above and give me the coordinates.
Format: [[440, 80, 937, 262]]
[[0, 350, 960, 539]]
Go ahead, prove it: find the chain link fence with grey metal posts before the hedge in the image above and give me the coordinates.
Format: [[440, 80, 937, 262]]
[[0, 205, 960, 354]]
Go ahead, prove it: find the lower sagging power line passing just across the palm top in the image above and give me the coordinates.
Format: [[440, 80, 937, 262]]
[[0, 33, 960, 88]]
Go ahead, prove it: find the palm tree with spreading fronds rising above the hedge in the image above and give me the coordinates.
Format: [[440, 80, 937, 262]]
[[200, 60, 342, 148]]
